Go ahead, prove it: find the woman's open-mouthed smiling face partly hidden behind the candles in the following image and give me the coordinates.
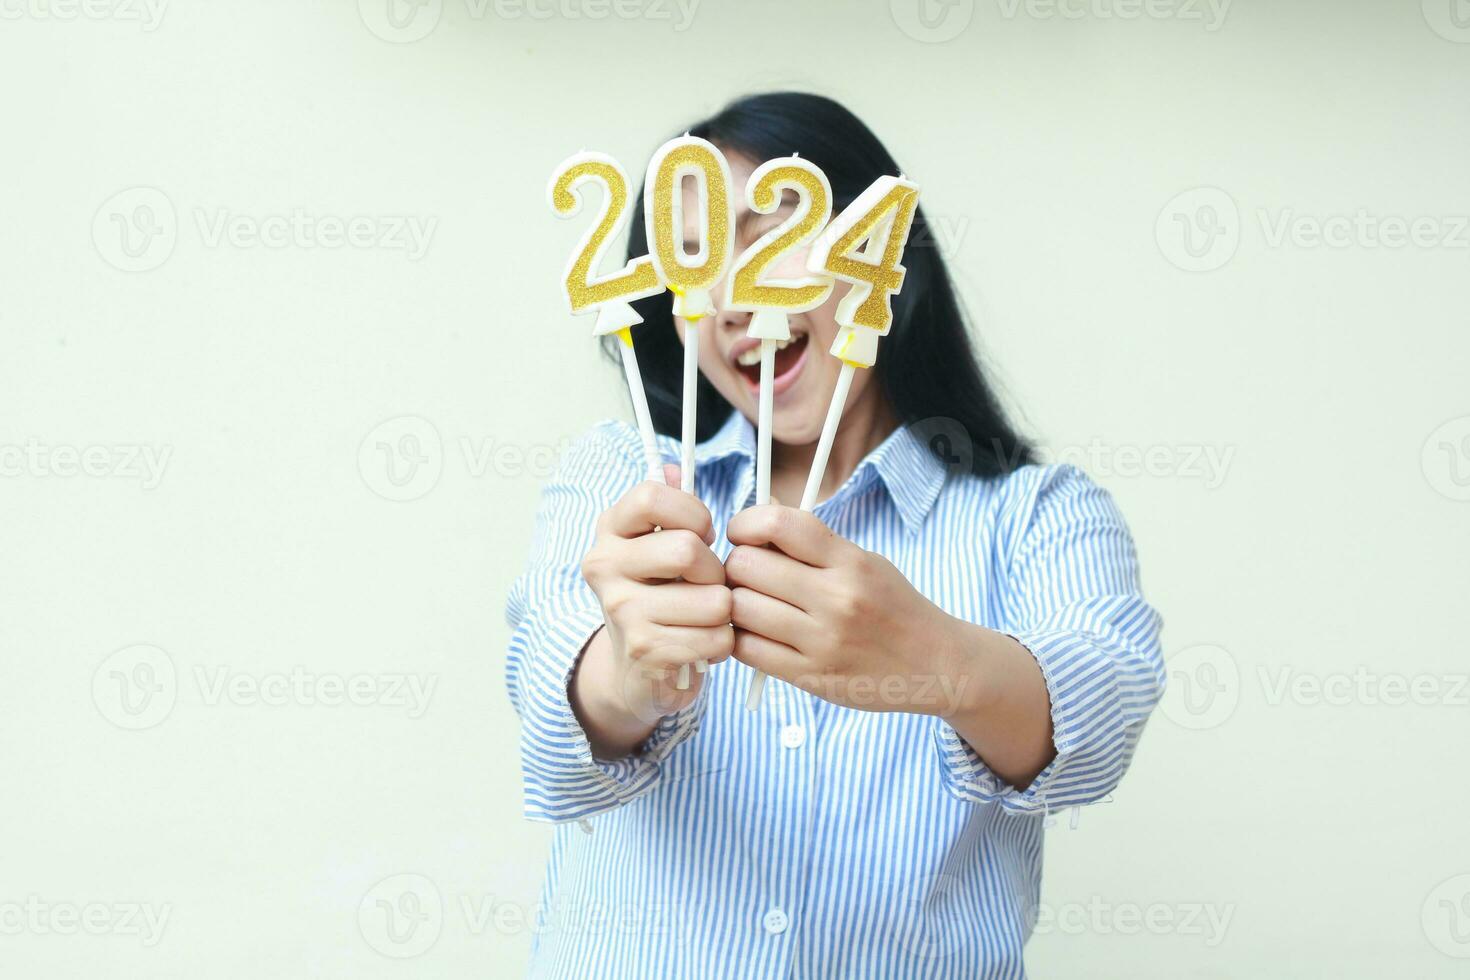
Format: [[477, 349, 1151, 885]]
[[675, 153, 872, 445]]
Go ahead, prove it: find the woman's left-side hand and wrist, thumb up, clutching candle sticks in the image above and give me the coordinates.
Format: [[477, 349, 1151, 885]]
[[569, 466, 735, 758]]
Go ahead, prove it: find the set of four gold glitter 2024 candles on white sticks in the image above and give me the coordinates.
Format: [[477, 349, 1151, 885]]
[[548, 143, 919, 710]]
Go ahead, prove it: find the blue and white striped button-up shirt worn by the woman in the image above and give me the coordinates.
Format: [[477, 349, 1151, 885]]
[[506, 413, 1164, 979]]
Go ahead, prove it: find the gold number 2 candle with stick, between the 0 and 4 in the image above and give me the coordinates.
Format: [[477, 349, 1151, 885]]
[[728, 156, 833, 711]]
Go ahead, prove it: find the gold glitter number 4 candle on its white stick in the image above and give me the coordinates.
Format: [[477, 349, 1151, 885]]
[[745, 176, 919, 710]]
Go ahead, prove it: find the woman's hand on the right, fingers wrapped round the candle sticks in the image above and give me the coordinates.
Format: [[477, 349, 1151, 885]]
[[725, 505, 978, 716]]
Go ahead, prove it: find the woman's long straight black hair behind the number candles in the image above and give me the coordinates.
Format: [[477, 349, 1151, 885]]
[[604, 93, 1035, 476]]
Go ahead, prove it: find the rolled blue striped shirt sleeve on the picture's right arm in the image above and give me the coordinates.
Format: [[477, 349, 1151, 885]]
[[936, 466, 1164, 813]]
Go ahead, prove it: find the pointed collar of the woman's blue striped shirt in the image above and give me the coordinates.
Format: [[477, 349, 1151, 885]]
[[694, 411, 945, 532]]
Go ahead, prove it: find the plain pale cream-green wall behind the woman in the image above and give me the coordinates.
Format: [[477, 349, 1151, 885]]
[[0, 0, 1470, 979]]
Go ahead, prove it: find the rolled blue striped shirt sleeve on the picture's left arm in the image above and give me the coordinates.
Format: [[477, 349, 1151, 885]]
[[506, 422, 704, 823]]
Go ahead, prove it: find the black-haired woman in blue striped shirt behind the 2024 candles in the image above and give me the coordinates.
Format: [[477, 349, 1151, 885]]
[[507, 93, 1164, 977]]
